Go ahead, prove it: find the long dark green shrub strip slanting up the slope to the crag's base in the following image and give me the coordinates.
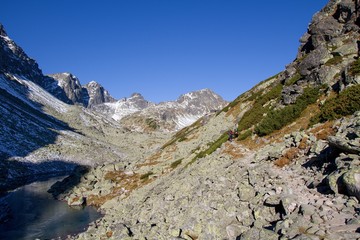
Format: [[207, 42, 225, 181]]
[[255, 87, 320, 136]]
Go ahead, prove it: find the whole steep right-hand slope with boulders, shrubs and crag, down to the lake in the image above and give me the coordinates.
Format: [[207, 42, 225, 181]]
[[54, 0, 360, 240]]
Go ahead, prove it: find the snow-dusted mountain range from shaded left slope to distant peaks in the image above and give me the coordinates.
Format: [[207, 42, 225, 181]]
[[0, 21, 226, 191]]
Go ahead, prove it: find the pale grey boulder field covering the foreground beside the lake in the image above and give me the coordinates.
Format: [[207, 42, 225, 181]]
[[57, 113, 360, 240]]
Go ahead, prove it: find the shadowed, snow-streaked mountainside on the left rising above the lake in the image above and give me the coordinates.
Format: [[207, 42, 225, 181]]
[[0, 25, 139, 191]]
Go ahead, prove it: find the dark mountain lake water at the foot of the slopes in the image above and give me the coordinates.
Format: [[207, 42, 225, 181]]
[[0, 178, 101, 240]]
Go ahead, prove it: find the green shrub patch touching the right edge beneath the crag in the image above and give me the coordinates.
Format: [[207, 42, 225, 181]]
[[310, 84, 360, 125]]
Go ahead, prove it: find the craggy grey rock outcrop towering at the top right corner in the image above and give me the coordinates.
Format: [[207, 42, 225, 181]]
[[281, 0, 360, 104]]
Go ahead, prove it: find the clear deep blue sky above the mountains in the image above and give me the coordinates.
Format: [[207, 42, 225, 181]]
[[0, 0, 328, 102]]
